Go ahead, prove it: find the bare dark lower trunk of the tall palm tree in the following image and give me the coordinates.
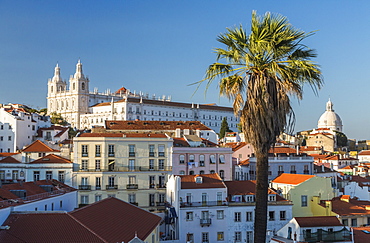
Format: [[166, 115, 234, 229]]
[[254, 152, 268, 243]]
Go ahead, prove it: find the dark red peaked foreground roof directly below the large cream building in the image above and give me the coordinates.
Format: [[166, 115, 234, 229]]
[[70, 197, 161, 243]]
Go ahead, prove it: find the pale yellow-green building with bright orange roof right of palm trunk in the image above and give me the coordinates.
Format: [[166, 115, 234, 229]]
[[271, 173, 335, 217]]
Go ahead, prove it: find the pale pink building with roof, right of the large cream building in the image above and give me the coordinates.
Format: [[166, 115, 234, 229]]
[[172, 135, 233, 181]]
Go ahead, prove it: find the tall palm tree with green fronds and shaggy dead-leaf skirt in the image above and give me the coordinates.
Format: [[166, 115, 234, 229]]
[[199, 11, 323, 243]]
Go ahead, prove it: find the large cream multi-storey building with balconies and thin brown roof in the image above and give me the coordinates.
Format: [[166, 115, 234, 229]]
[[73, 133, 173, 211]]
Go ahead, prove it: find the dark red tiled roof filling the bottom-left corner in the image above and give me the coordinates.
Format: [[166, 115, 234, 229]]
[[0, 212, 107, 242]]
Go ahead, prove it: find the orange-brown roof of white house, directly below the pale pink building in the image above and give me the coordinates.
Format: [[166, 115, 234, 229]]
[[180, 173, 226, 189]]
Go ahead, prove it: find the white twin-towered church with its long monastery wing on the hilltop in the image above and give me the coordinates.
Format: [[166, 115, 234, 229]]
[[47, 61, 239, 132]]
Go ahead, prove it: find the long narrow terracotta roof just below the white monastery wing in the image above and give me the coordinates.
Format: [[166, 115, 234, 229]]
[[105, 121, 212, 131]]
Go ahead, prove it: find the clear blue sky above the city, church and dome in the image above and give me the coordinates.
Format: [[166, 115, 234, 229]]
[[0, 0, 370, 140]]
